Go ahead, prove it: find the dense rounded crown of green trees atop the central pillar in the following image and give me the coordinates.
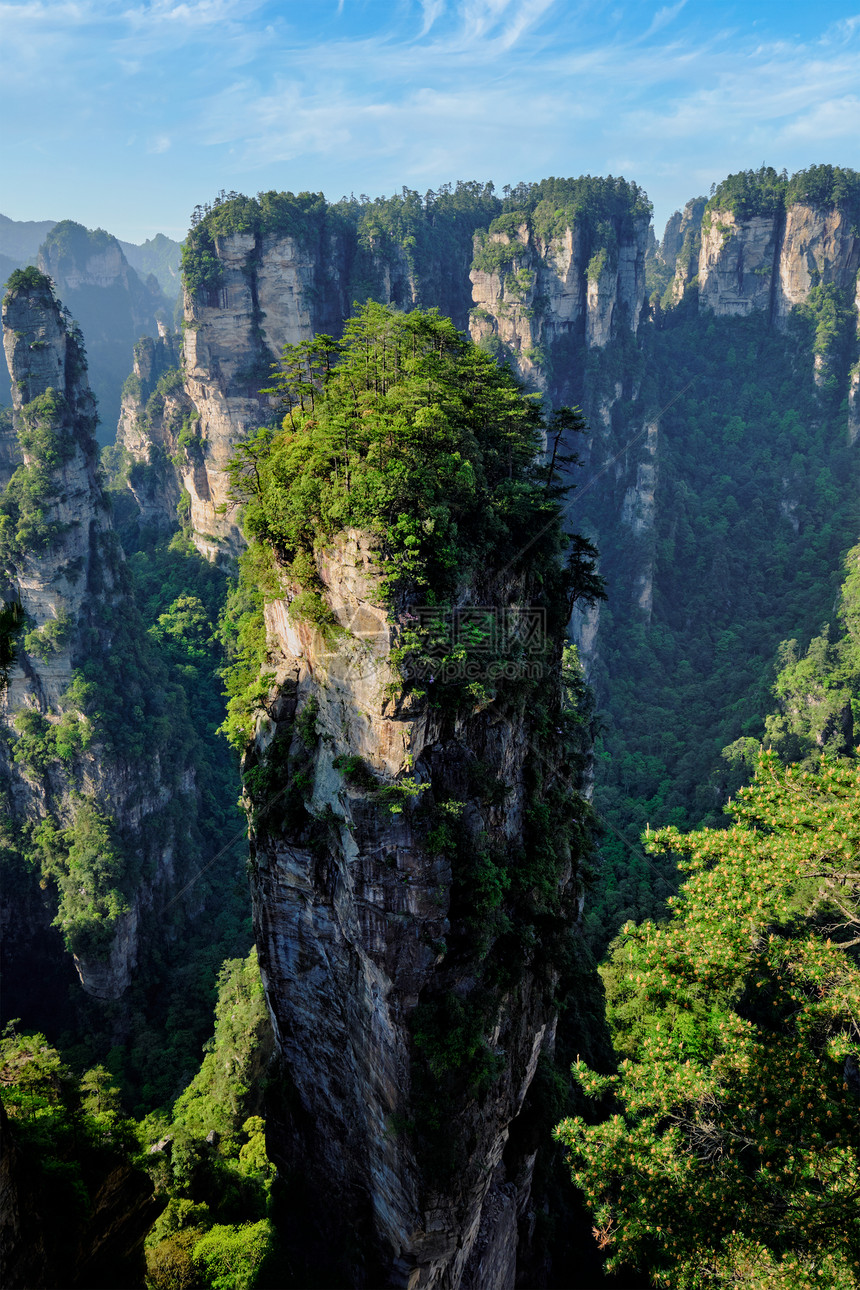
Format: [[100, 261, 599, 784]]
[[231, 304, 567, 599]]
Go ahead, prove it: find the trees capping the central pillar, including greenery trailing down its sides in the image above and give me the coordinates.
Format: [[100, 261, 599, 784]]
[[224, 302, 603, 746]]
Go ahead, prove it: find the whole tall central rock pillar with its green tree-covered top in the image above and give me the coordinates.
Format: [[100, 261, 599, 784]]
[[232, 311, 598, 1290]]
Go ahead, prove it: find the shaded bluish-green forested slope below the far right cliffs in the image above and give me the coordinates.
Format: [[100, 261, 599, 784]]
[[585, 301, 860, 952]]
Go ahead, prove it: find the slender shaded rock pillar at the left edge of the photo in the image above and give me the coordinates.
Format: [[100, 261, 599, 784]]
[[0, 271, 195, 998]]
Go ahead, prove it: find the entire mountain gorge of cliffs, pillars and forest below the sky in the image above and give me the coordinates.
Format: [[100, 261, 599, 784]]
[[0, 164, 860, 1290]]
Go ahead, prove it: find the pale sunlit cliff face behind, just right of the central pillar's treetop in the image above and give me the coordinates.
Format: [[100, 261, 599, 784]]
[[469, 208, 649, 390]]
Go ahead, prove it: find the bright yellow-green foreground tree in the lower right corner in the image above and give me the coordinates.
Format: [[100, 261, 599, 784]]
[[557, 753, 860, 1290]]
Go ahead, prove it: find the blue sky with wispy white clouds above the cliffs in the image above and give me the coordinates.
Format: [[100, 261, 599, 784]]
[[0, 0, 860, 241]]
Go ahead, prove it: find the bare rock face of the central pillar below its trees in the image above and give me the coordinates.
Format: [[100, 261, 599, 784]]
[[248, 530, 582, 1290]]
